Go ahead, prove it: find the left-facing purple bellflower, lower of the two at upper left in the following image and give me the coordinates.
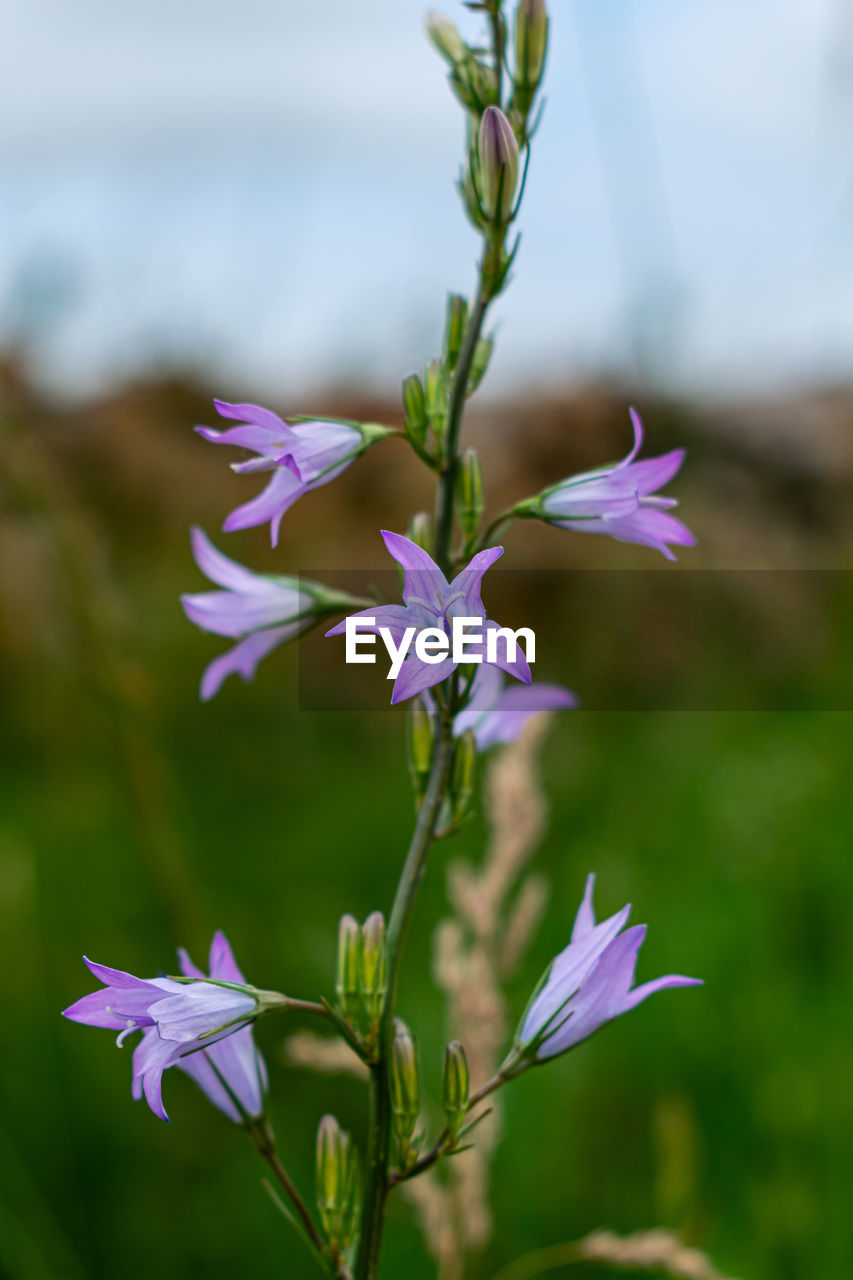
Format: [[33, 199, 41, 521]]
[[181, 527, 360, 701]]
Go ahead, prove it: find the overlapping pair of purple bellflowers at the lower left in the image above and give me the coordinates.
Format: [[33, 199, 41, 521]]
[[63, 933, 263, 1120]]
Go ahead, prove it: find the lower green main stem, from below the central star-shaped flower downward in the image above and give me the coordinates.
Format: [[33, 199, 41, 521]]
[[355, 709, 453, 1280]]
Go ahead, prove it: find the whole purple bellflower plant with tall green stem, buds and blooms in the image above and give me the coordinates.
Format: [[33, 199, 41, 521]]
[[64, 0, 697, 1280]]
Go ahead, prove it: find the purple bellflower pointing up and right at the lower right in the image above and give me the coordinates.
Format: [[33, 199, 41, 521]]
[[516, 876, 701, 1061]]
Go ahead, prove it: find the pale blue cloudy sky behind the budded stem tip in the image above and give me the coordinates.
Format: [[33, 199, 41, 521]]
[[0, 0, 853, 403]]
